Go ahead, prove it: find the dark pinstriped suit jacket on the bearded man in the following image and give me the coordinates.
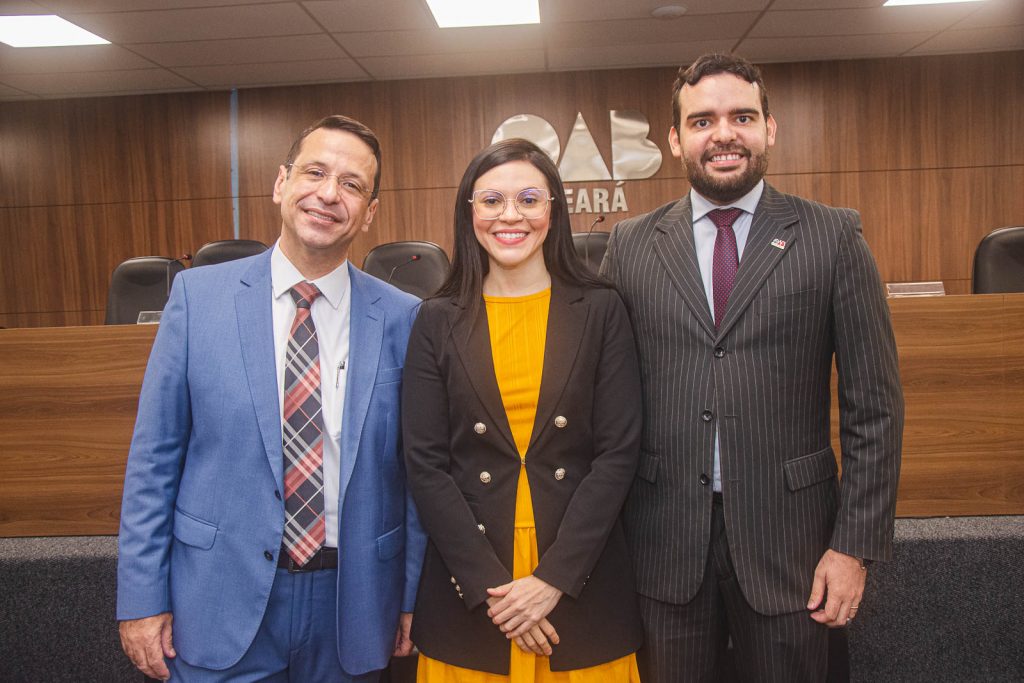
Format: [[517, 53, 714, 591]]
[[602, 184, 903, 614]]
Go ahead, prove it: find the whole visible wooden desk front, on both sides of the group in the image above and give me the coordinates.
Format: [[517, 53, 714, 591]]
[[0, 294, 1024, 537]]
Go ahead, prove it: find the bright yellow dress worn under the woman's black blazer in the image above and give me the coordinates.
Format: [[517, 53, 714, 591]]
[[416, 289, 640, 683]]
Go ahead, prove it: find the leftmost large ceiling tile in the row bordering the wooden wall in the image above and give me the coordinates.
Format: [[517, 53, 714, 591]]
[[3, 69, 196, 96]]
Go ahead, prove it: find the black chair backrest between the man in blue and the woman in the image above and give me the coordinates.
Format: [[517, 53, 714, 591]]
[[362, 241, 449, 299]]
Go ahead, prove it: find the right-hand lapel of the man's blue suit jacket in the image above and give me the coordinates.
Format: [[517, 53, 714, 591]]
[[338, 263, 384, 501]]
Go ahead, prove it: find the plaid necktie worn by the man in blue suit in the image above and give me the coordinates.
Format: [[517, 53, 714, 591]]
[[282, 282, 327, 565]]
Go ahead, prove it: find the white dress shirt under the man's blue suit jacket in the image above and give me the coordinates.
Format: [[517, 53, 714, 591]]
[[270, 244, 352, 548]]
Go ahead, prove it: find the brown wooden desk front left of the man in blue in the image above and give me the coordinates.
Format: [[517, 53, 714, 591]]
[[0, 325, 157, 537]]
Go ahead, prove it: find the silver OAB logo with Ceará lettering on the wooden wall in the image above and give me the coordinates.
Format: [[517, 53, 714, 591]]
[[490, 110, 662, 214]]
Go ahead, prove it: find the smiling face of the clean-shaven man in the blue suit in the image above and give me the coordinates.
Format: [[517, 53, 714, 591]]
[[273, 128, 379, 280]]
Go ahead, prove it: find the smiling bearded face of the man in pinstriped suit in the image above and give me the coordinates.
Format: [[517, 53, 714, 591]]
[[669, 73, 775, 205]]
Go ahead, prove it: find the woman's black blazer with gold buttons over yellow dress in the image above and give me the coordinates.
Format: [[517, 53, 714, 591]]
[[402, 282, 642, 674]]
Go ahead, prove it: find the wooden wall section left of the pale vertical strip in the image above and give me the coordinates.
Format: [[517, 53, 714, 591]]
[[0, 93, 233, 327]]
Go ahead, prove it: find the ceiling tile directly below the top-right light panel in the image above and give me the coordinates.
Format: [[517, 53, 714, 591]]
[[751, 3, 971, 37]]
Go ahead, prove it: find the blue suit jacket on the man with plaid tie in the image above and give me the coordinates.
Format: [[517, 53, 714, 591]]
[[118, 251, 426, 675]]
